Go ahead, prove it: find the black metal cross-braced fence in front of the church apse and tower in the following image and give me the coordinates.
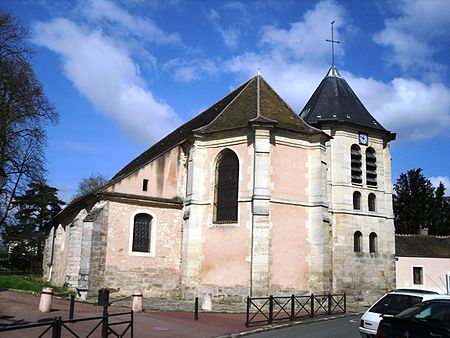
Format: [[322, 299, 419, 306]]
[[245, 293, 347, 327]]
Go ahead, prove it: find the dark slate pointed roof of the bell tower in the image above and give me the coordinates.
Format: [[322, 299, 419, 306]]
[[300, 66, 389, 133]]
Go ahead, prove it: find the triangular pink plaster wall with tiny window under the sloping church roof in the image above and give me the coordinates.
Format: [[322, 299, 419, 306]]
[[108, 147, 179, 198]]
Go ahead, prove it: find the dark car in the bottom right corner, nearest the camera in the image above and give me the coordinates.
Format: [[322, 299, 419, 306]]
[[377, 299, 450, 338]]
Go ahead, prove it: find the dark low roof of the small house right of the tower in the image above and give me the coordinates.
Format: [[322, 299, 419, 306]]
[[395, 235, 450, 258]]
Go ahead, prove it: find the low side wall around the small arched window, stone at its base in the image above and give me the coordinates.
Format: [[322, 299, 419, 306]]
[[104, 202, 182, 297]]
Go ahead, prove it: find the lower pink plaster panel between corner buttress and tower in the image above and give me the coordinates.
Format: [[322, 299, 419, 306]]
[[270, 203, 308, 290]]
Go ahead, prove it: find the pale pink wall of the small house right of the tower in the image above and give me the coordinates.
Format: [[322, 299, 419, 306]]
[[395, 257, 450, 293]]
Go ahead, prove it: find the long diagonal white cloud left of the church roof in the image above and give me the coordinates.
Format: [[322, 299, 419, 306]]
[[33, 18, 181, 143]]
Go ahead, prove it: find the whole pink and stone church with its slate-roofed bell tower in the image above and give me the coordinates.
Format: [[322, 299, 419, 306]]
[[43, 66, 395, 304]]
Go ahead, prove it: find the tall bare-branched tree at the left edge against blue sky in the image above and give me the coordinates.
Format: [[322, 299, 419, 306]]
[[0, 11, 58, 228]]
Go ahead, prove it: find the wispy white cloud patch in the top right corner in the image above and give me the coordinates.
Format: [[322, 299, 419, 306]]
[[374, 0, 450, 80]]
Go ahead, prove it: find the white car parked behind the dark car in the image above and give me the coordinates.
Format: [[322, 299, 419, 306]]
[[359, 289, 450, 338]]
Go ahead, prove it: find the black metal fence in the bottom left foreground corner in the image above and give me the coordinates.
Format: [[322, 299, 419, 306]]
[[0, 305, 134, 338]]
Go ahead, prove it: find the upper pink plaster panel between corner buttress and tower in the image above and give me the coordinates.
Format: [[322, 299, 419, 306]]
[[272, 144, 307, 202]]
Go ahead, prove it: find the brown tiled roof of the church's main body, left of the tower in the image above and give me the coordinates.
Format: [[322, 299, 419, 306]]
[[112, 75, 321, 181]]
